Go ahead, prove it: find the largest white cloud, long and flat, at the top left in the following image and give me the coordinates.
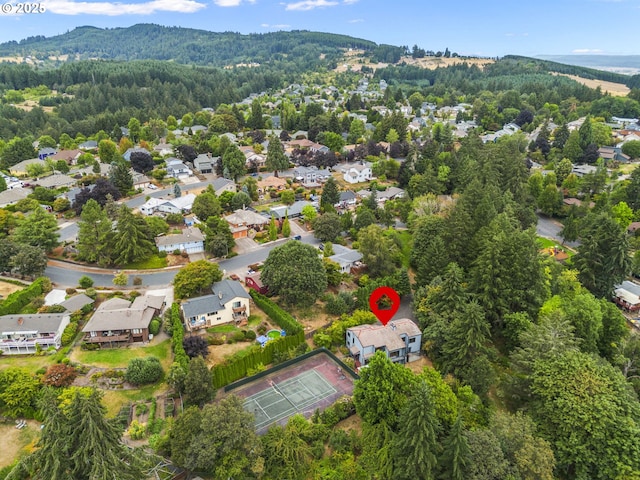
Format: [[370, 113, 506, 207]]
[[43, 0, 206, 17]]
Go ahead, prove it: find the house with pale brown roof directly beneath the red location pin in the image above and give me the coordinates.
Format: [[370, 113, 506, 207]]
[[346, 318, 422, 367]]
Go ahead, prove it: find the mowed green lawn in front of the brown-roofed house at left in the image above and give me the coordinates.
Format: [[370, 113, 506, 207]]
[[72, 340, 172, 371]]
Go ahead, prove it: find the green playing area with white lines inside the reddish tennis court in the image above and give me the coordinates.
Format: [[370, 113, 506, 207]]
[[245, 370, 336, 429]]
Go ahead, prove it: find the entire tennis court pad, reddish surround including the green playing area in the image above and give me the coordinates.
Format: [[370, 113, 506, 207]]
[[229, 353, 354, 434]]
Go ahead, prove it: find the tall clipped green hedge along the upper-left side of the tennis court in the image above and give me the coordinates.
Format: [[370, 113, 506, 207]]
[[211, 332, 304, 388]]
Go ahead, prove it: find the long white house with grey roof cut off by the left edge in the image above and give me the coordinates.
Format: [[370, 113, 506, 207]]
[[0, 312, 71, 355]]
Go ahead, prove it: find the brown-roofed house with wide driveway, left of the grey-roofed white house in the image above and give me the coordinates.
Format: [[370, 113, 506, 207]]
[[82, 295, 165, 347]]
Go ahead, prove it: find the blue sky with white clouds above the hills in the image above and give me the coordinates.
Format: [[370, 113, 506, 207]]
[[0, 0, 640, 56]]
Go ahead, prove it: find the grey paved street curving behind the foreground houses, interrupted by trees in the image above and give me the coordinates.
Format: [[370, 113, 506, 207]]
[[45, 232, 320, 287]]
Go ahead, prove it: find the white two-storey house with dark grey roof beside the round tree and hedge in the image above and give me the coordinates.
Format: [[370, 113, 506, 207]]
[[180, 280, 251, 332]]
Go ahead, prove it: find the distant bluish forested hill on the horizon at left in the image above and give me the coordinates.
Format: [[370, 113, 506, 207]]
[[0, 24, 378, 66]]
